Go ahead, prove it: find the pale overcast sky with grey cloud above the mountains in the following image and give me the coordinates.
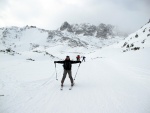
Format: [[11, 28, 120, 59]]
[[0, 0, 150, 33]]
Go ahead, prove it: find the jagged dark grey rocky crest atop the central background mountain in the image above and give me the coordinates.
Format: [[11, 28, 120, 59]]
[[60, 22, 115, 38]]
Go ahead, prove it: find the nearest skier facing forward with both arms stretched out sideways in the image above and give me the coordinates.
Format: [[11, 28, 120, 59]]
[[54, 56, 81, 87]]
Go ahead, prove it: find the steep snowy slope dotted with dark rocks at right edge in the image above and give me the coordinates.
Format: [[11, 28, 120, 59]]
[[121, 20, 150, 52]]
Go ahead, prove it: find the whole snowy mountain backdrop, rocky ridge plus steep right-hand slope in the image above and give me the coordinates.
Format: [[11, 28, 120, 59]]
[[0, 21, 150, 58]]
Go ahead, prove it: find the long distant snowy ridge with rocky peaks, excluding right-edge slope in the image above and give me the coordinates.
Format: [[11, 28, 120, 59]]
[[0, 22, 125, 51]]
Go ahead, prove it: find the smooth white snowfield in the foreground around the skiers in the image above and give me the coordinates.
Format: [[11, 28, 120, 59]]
[[0, 36, 150, 113]]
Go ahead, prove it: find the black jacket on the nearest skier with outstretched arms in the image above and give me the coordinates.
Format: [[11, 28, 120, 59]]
[[54, 60, 81, 70]]
